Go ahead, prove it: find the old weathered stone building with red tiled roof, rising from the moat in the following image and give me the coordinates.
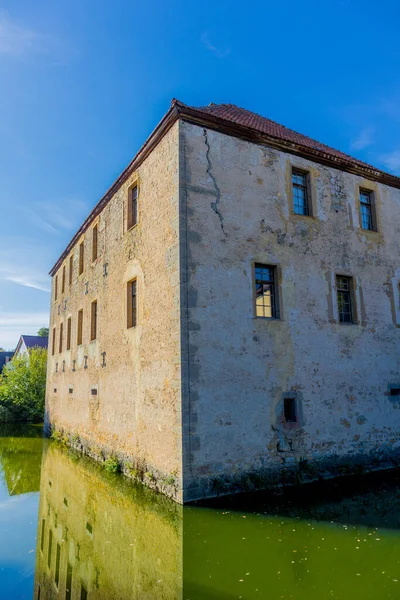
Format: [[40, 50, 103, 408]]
[[46, 100, 400, 502]]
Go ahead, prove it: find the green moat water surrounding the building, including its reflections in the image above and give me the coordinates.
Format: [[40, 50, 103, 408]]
[[0, 427, 400, 600]]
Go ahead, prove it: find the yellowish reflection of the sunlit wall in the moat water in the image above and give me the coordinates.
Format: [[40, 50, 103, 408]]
[[34, 444, 182, 600]]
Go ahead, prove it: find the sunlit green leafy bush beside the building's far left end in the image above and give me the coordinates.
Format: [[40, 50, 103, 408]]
[[0, 348, 47, 422]]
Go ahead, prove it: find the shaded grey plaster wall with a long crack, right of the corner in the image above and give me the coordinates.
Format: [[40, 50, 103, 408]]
[[181, 124, 400, 500]]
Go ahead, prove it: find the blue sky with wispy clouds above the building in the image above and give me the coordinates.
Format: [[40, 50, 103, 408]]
[[0, 0, 400, 348]]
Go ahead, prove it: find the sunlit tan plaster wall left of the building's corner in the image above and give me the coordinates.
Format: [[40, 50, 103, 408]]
[[46, 123, 182, 499]]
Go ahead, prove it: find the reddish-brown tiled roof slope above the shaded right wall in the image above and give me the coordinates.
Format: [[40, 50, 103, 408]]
[[173, 101, 394, 181]]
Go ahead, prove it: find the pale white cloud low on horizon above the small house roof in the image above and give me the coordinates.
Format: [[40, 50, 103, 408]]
[[0, 310, 49, 350]]
